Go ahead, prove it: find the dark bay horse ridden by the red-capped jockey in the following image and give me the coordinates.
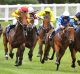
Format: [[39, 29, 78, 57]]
[[3, 18, 25, 66]]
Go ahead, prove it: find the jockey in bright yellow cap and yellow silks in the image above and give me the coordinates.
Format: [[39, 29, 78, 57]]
[[36, 7, 55, 32]]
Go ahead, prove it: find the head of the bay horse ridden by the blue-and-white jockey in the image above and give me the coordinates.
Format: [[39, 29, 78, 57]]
[[64, 27, 75, 43]]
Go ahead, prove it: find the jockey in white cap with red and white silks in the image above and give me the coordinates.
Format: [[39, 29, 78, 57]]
[[28, 7, 38, 34]]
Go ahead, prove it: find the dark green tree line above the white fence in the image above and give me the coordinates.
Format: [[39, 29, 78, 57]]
[[0, 0, 80, 5]]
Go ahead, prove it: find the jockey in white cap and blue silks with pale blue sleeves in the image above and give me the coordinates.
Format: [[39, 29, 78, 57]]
[[50, 11, 74, 40]]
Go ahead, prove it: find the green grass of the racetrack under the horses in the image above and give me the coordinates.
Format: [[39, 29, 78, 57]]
[[0, 22, 80, 74]]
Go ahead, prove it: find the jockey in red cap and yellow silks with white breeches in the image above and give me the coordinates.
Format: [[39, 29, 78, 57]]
[[7, 6, 29, 33]]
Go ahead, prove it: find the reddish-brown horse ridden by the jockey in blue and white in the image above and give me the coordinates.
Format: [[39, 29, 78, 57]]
[[41, 27, 74, 70]]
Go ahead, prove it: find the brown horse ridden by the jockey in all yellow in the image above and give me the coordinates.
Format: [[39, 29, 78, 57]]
[[38, 15, 53, 59]]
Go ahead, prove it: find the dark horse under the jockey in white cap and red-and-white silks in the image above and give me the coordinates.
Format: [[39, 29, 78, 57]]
[[25, 18, 37, 61]]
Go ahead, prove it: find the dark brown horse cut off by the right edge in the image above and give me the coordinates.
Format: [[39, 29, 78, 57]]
[[69, 26, 80, 68]]
